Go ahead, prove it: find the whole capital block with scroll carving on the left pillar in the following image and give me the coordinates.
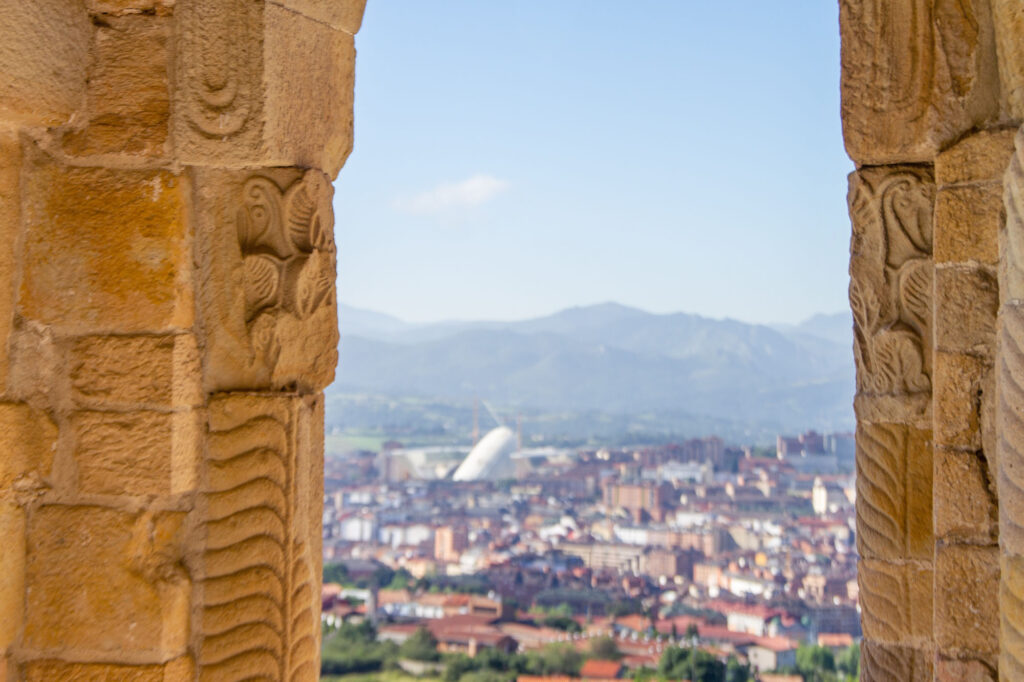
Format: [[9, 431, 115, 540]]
[[194, 169, 338, 392]]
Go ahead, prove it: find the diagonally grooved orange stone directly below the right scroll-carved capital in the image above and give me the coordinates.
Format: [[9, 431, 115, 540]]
[[857, 423, 933, 560]]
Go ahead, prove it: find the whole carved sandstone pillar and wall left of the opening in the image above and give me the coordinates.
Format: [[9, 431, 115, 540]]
[[0, 0, 365, 681]]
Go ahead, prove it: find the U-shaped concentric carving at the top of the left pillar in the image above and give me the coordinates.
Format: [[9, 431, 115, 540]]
[[175, 0, 261, 138]]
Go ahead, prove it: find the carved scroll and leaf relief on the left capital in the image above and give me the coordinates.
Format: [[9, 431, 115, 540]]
[[237, 171, 336, 367]]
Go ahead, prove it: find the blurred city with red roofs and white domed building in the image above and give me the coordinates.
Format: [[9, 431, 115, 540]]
[[323, 417, 861, 682]]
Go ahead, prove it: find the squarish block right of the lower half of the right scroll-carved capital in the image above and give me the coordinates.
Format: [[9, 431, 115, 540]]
[[935, 266, 999, 357]]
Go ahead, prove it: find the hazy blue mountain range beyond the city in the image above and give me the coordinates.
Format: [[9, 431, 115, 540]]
[[329, 303, 854, 430]]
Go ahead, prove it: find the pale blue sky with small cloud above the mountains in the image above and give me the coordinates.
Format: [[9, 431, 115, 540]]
[[335, 0, 853, 323]]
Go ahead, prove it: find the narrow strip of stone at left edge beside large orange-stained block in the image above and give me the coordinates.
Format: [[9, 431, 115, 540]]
[[0, 131, 22, 387]]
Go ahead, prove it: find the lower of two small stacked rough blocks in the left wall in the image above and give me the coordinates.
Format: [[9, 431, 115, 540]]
[[72, 405, 201, 496]]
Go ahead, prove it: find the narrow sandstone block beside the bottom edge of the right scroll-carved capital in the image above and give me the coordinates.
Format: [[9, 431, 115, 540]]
[[934, 351, 995, 450]]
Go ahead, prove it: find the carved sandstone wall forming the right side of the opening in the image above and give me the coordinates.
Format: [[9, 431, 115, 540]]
[[840, 0, 1024, 681]]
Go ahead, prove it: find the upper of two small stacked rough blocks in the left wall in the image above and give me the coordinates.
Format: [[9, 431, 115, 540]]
[[70, 334, 203, 409]]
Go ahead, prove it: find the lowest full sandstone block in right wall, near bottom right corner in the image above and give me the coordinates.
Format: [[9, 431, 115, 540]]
[[935, 545, 999, 655]]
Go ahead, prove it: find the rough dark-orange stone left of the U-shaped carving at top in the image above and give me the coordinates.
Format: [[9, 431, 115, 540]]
[[63, 14, 171, 156]]
